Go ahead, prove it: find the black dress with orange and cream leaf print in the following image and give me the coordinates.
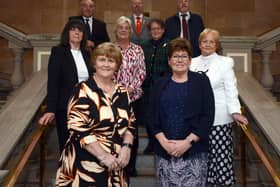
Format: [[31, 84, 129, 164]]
[[56, 78, 135, 187]]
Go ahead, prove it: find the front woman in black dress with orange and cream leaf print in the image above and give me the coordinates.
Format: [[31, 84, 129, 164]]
[[56, 43, 135, 187]]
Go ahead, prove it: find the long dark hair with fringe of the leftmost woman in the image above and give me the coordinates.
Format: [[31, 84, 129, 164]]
[[59, 19, 87, 49]]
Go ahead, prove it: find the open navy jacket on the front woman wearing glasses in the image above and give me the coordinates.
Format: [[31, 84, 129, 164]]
[[148, 71, 215, 159]]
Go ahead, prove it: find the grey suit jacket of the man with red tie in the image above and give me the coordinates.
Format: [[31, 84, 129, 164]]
[[129, 16, 151, 45]]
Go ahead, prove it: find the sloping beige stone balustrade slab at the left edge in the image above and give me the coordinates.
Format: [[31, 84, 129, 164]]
[[0, 71, 47, 167]]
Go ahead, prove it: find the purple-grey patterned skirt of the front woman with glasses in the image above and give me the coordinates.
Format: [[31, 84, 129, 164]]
[[156, 153, 207, 187]]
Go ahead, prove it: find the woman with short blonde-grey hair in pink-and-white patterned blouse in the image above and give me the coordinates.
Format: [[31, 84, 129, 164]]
[[115, 16, 146, 176]]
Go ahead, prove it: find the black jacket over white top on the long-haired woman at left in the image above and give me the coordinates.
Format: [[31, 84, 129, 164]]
[[46, 46, 92, 113]]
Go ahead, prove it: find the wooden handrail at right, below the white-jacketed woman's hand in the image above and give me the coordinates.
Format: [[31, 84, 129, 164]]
[[240, 124, 280, 187]]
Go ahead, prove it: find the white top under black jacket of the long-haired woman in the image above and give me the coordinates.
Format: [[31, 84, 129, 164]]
[[71, 49, 89, 83]]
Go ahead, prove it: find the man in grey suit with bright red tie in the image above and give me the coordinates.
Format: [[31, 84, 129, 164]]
[[130, 0, 151, 44]]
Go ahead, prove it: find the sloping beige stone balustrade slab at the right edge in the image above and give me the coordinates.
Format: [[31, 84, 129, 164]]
[[237, 73, 280, 154]]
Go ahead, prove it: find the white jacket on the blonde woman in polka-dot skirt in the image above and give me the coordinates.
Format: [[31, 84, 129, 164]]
[[190, 53, 240, 125]]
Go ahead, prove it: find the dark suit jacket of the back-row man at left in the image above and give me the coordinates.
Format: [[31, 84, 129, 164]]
[[69, 16, 110, 46]]
